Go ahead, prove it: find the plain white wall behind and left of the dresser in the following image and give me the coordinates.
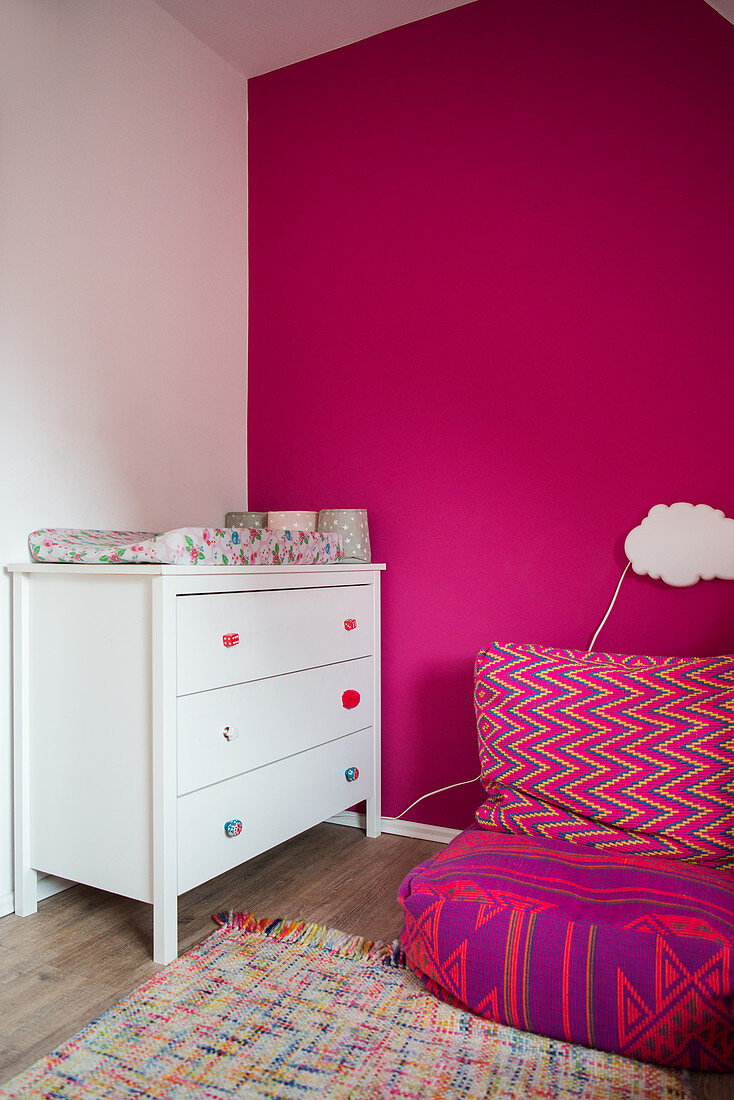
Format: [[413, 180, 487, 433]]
[[0, 0, 247, 913]]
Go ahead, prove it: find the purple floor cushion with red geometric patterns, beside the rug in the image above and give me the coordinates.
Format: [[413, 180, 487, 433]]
[[399, 826, 734, 1070]]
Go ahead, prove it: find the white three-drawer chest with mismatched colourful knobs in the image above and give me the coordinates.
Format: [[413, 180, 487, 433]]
[[9, 564, 383, 963]]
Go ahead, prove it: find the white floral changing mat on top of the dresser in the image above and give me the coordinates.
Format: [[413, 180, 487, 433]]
[[28, 527, 344, 565]]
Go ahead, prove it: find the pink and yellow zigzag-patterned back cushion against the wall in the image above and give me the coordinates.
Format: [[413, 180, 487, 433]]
[[474, 642, 734, 869]]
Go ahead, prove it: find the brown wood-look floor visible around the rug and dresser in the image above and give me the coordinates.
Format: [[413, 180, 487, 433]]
[[0, 824, 734, 1100]]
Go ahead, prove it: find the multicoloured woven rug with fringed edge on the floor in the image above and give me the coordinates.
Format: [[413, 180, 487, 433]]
[[0, 914, 693, 1100]]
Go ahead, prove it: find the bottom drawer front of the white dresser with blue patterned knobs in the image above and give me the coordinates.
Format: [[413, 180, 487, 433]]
[[178, 729, 374, 894]]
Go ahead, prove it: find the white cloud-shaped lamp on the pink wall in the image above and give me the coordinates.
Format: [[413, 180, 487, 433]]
[[624, 502, 734, 589]]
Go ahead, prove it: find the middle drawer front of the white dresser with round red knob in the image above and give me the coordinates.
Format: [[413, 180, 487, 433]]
[[177, 657, 374, 794]]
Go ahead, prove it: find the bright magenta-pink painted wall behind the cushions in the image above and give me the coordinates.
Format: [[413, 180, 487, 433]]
[[249, 0, 734, 827]]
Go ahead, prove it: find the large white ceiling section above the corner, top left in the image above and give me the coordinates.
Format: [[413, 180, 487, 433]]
[[156, 0, 474, 76]]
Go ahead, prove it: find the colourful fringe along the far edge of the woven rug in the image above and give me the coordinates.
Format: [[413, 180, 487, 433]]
[[213, 910, 406, 970]]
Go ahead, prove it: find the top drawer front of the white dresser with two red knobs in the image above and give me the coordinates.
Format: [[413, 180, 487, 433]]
[[176, 585, 374, 695]]
